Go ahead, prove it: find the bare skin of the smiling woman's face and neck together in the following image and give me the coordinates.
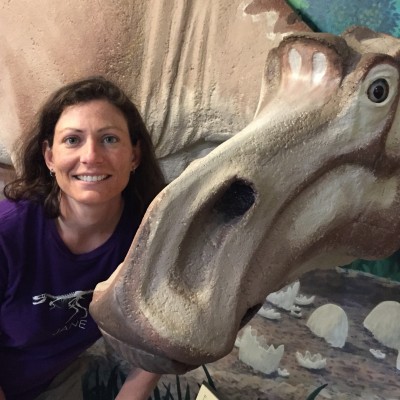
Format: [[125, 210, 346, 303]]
[[43, 100, 141, 253]]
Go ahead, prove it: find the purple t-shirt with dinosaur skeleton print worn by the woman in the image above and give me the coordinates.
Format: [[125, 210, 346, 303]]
[[0, 200, 140, 400]]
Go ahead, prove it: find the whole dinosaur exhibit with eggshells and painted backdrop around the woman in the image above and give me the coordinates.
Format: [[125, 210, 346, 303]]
[[0, 0, 400, 400]]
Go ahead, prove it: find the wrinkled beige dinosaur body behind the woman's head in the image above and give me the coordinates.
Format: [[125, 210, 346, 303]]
[[0, 0, 308, 181]]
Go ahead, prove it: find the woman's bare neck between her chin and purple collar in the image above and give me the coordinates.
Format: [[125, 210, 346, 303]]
[[56, 197, 124, 254]]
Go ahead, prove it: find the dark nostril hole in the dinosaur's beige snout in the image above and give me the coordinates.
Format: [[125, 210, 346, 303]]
[[214, 180, 256, 222]]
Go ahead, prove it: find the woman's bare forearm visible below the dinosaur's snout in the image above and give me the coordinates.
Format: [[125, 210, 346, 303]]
[[115, 368, 161, 400]]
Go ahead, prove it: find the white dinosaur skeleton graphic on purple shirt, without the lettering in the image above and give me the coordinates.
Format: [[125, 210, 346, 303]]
[[32, 290, 93, 323]]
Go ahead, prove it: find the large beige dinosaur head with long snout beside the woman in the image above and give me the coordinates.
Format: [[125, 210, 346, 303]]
[[90, 28, 400, 373]]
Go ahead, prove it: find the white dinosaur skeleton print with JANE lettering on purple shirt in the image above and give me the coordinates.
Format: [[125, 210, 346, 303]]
[[32, 290, 93, 335]]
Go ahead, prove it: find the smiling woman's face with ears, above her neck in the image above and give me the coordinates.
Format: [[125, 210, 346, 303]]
[[43, 100, 141, 211]]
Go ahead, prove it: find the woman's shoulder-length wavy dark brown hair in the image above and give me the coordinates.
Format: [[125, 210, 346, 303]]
[[4, 76, 165, 218]]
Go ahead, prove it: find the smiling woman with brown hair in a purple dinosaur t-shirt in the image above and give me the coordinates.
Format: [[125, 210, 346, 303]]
[[0, 77, 164, 400]]
